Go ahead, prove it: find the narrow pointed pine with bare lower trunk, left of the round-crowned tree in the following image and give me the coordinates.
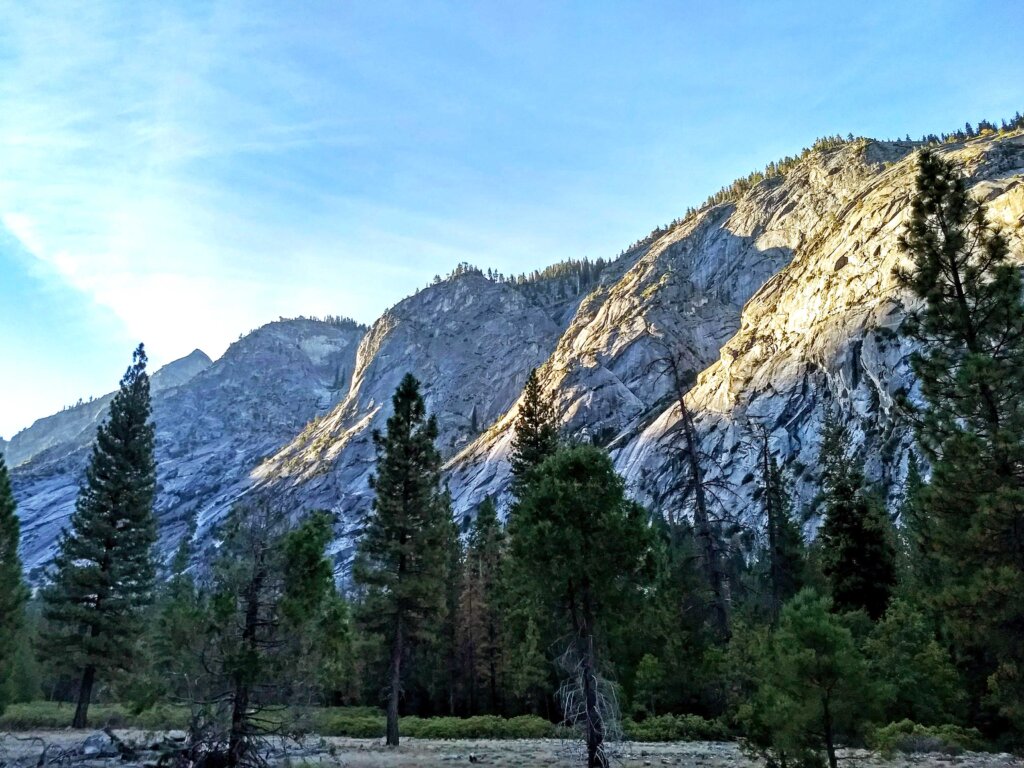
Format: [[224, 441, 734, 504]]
[[353, 374, 452, 746]]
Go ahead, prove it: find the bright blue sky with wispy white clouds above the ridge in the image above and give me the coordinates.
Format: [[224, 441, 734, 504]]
[[0, 0, 1024, 438]]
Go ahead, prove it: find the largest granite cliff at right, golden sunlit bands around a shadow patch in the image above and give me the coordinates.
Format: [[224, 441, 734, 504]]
[[449, 137, 1024, 525]]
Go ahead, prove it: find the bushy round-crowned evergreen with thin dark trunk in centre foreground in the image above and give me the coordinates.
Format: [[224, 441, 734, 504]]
[[510, 445, 651, 768]]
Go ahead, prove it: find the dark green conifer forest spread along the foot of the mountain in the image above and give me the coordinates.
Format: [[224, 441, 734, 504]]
[[0, 150, 1024, 768]]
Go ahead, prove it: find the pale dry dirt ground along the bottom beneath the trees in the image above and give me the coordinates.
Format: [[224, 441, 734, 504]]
[[0, 730, 1024, 768]]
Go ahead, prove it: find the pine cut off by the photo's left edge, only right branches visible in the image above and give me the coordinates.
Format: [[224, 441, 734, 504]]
[[0, 455, 29, 713]]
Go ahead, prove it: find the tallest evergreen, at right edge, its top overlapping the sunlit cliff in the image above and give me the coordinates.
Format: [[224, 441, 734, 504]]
[[896, 152, 1024, 732]]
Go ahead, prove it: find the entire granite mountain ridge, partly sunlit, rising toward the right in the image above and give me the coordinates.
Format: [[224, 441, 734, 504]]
[[13, 131, 1024, 566]]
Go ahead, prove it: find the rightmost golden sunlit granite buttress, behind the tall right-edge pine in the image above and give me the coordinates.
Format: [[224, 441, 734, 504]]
[[614, 137, 1024, 525]]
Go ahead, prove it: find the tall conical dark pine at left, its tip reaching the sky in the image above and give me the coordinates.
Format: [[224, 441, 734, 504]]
[[42, 344, 157, 728]]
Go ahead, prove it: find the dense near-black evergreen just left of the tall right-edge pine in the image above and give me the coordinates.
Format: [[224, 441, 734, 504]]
[[818, 418, 896, 621]]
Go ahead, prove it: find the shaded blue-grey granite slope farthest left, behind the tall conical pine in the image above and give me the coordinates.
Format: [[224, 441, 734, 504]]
[[11, 319, 364, 575]]
